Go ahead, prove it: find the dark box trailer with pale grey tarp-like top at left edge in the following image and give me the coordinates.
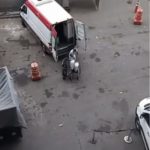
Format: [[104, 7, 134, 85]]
[[0, 67, 25, 140]]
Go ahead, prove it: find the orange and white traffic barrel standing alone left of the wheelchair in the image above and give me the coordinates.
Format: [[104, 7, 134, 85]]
[[31, 62, 41, 81]]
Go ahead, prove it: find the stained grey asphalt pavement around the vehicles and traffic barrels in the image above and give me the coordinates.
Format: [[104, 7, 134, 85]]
[[0, 0, 149, 150]]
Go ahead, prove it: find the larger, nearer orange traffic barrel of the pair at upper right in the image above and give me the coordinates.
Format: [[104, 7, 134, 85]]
[[133, 7, 143, 25]]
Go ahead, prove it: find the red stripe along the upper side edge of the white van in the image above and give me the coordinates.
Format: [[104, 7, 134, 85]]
[[25, 0, 57, 37]]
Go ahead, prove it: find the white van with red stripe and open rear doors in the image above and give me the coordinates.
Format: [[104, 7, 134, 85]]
[[20, 0, 86, 61]]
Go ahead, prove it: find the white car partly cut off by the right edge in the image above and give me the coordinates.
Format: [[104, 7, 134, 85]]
[[135, 97, 150, 150]]
